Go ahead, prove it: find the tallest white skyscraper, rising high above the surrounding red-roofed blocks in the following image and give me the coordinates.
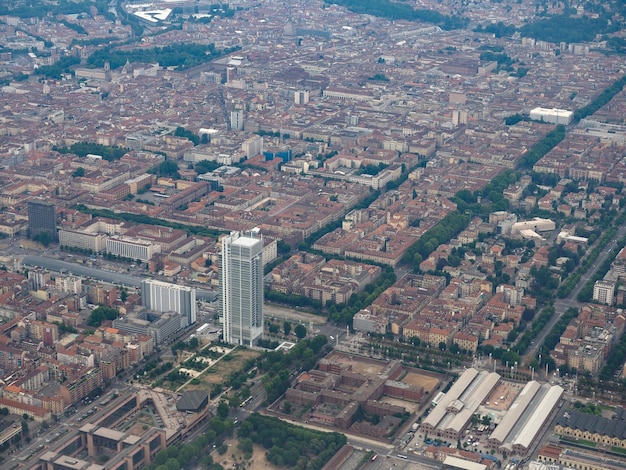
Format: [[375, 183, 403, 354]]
[[220, 228, 263, 346]]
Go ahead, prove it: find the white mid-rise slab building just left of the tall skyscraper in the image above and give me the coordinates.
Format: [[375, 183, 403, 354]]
[[141, 279, 196, 326]]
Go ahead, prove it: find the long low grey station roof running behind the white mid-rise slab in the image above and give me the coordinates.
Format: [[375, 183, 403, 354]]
[[22, 255, 217, 301]]
